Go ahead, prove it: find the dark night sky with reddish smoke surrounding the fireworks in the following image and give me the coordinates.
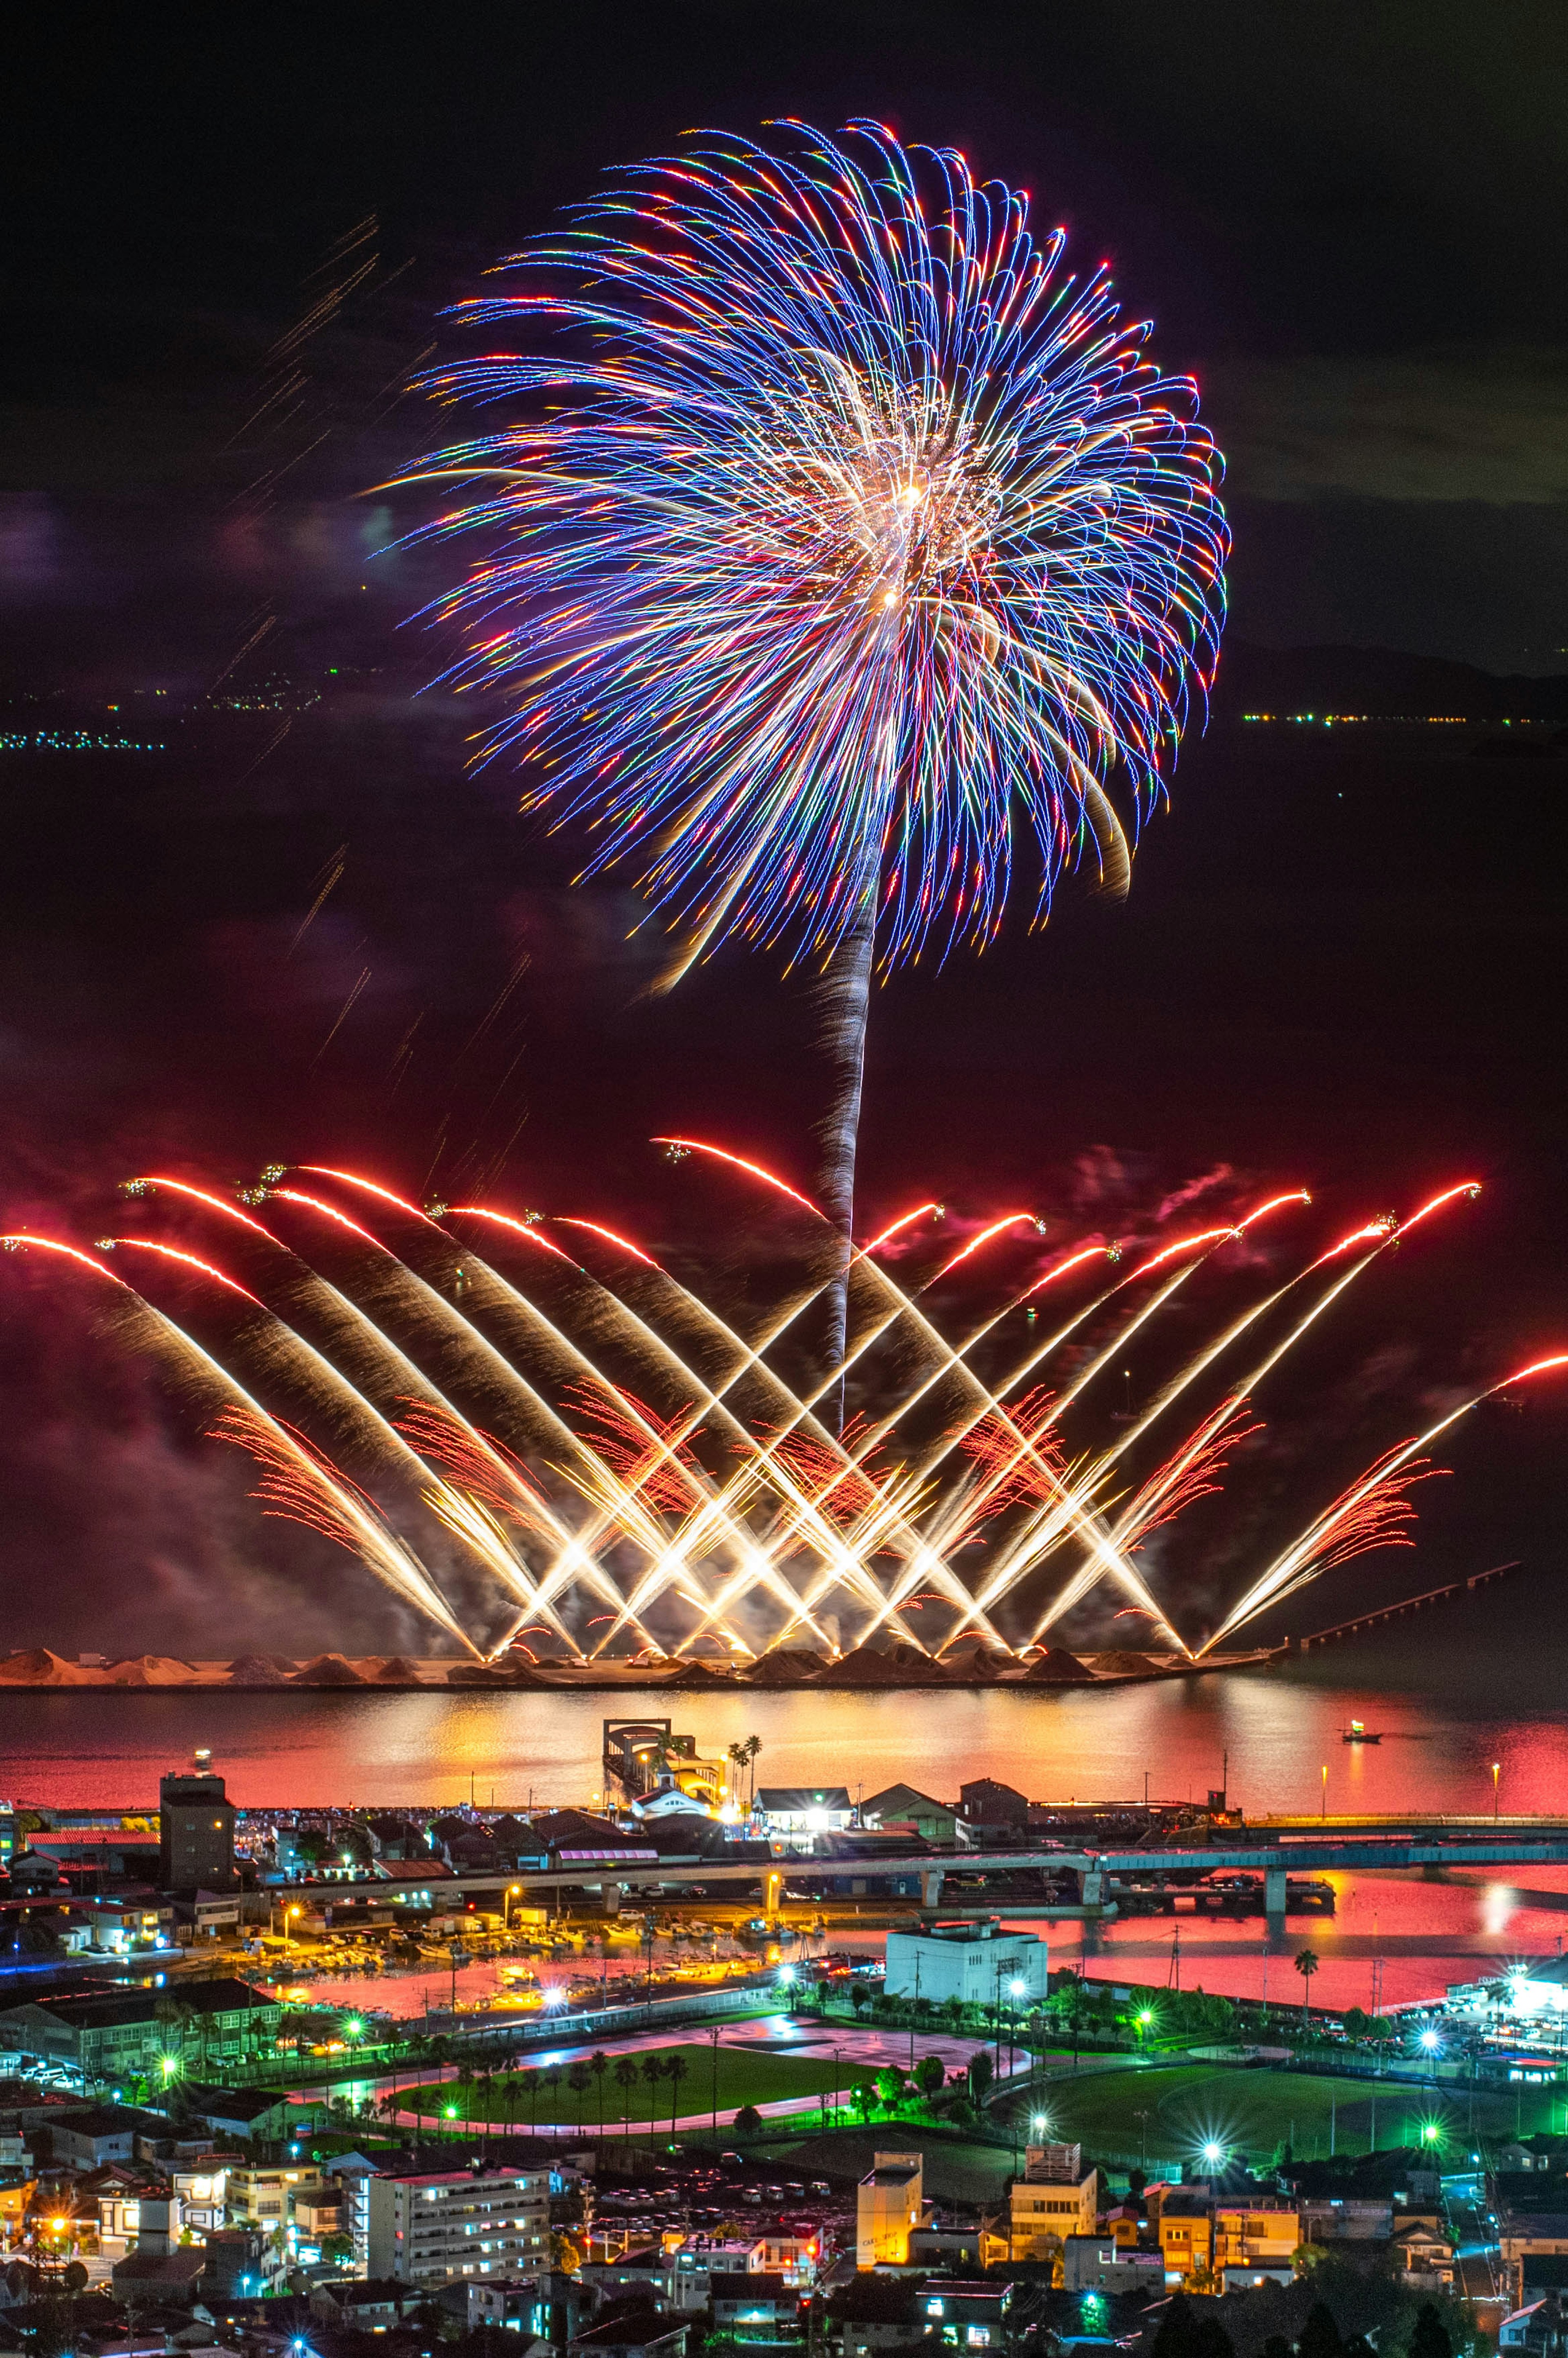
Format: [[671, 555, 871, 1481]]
[[0, 0, 1568, 1651]]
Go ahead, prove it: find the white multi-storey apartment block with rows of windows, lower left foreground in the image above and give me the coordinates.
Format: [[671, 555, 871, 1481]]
[[368, 2169, 549, 2285]]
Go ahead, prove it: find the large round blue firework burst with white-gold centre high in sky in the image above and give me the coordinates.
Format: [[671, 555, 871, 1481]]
[[420, 122, 1228, 964]]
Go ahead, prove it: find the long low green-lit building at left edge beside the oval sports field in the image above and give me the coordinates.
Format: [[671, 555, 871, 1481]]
[[0, 1981, 283, 2087]]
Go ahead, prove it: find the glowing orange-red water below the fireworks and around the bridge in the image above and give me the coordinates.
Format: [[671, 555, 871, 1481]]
[[0, 1672, 1568, 2011]]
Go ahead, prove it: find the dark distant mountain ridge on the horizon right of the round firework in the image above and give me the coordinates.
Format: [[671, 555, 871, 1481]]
[[1214, 639, 1568, 724]]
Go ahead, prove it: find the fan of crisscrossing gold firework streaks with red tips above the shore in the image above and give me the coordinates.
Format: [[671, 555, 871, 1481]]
[[0, 1141, 1568, 1660]]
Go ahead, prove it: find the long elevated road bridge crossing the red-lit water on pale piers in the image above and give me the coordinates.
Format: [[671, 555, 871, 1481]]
[[287, 1816, 1568, 1917]]
